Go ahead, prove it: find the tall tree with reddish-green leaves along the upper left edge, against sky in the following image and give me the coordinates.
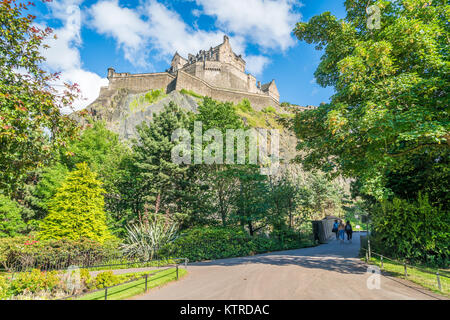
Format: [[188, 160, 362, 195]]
[[0, 0, 78, 194]]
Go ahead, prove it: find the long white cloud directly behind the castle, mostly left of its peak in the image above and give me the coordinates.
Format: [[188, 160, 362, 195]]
[[89, 0, 270, 75]]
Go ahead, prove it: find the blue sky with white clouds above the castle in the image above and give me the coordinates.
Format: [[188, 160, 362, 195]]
[[33, 0, 345, 109]]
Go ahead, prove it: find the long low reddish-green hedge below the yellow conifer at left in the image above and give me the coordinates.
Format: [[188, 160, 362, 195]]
[[0, 236, 116, 271]]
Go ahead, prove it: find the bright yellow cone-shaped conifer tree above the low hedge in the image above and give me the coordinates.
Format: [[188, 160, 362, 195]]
[[39, 163, 110, 243]]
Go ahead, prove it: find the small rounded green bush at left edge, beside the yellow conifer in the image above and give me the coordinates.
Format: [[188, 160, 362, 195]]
[[0, 194, 26, 238]]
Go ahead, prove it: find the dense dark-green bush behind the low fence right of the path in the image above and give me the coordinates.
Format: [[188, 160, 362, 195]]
[[373, 195, 450, 268]]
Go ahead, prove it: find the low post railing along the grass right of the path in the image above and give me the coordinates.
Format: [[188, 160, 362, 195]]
[[361, 247, 450, 294]]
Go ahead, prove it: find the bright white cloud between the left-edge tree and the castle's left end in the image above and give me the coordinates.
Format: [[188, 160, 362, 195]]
[[41, 0, 108, 110]]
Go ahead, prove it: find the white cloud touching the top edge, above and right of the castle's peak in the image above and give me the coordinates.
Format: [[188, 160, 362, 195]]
[[195, 0, 302, 51]]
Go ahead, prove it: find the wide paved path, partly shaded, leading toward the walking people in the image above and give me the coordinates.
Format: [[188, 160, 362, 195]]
[[134, 233, 443, 300]]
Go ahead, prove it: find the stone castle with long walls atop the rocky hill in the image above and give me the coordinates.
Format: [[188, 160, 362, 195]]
[[94, 36, 280, 109]]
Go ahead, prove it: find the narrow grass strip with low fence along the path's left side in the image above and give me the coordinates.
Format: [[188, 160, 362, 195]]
[[78, 268, 187, 300]]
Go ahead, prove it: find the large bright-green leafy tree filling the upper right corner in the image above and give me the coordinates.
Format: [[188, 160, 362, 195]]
[[293, 0, 450, 199]]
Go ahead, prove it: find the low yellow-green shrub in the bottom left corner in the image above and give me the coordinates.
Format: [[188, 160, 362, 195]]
[[9, 269, 60, 296]]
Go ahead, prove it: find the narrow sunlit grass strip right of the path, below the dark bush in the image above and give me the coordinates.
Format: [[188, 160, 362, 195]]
[[369, 256, 450, 296]]
